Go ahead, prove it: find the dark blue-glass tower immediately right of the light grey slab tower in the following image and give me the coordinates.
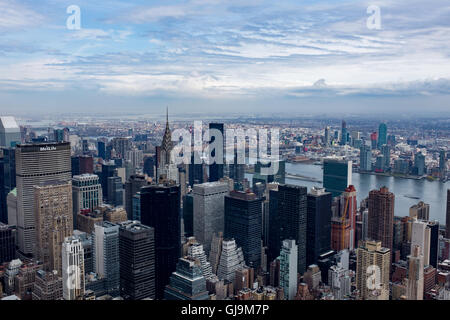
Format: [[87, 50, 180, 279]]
[[224, 191, 262, 270]]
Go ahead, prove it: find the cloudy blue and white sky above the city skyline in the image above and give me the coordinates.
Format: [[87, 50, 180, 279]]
[[0, 0, 450, 114]]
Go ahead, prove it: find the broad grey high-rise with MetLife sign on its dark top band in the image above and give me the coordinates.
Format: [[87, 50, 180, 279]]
[[16, 142, 72, 255]]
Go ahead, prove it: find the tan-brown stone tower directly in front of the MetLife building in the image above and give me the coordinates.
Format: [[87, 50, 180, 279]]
[[33, 181, 73, 276]]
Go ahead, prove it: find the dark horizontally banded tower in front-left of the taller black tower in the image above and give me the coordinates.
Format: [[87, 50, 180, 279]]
[[119, 221, 155, 300]]
